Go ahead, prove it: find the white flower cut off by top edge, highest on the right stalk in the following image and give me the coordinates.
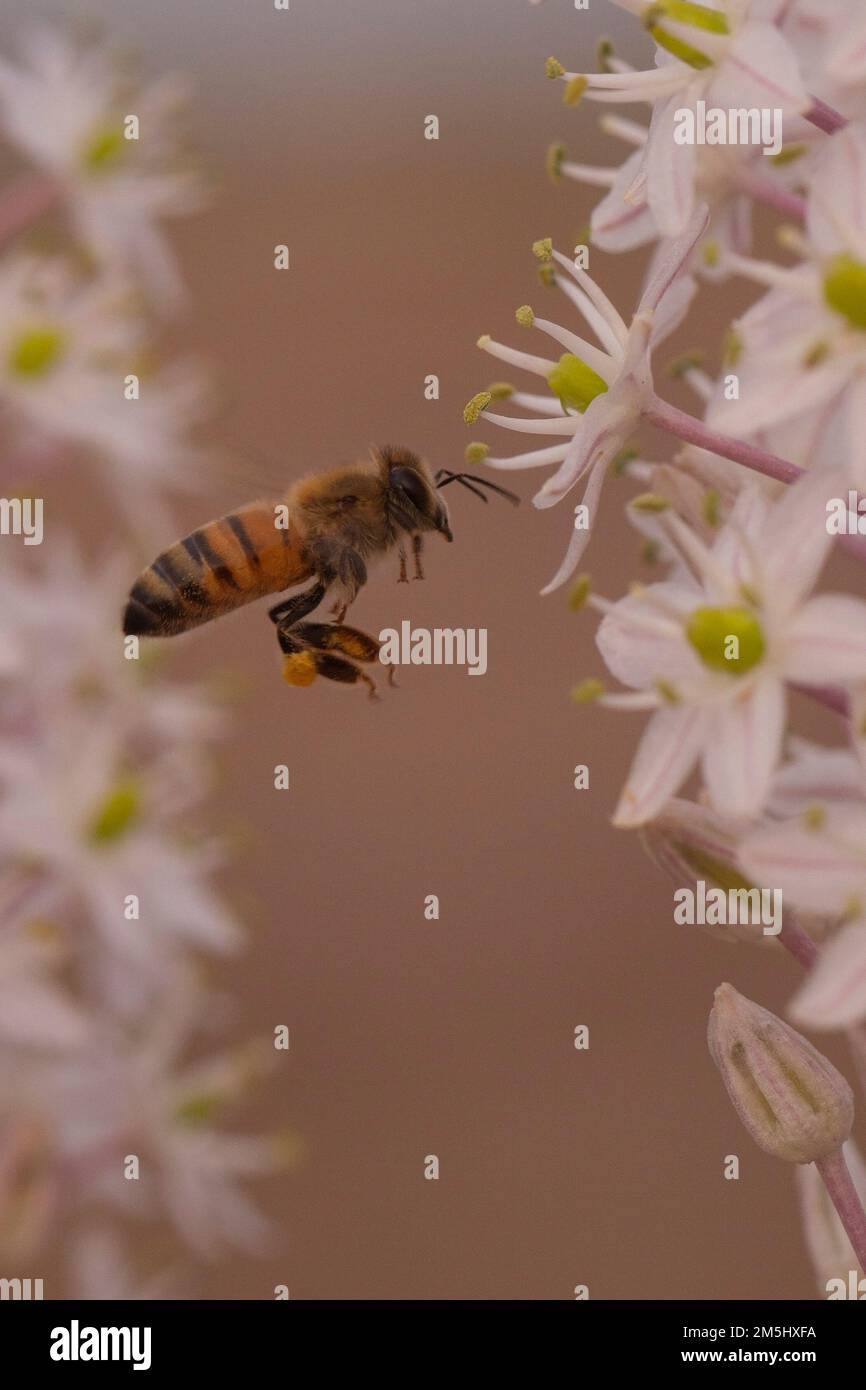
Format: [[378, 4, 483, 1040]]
[[548, 0, 812, 236]]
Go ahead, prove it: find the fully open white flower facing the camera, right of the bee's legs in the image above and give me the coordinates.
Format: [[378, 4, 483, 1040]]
[[588, 477, 866, 828]]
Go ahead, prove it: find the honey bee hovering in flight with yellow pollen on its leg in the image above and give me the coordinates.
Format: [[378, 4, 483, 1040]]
[[124, 446, 517, 696]]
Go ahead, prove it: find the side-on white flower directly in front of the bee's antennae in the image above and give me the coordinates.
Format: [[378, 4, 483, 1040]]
[[464, 209, 706, 594]]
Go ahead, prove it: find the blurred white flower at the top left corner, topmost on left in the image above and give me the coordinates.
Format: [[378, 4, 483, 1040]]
[[0, 26, 202, 307]]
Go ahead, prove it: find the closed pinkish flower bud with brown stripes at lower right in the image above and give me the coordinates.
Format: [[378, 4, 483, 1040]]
[[708, 984, 853, 1163]]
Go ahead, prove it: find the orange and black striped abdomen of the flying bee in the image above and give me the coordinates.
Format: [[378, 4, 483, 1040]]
[[124, 502, 313, 637]]
